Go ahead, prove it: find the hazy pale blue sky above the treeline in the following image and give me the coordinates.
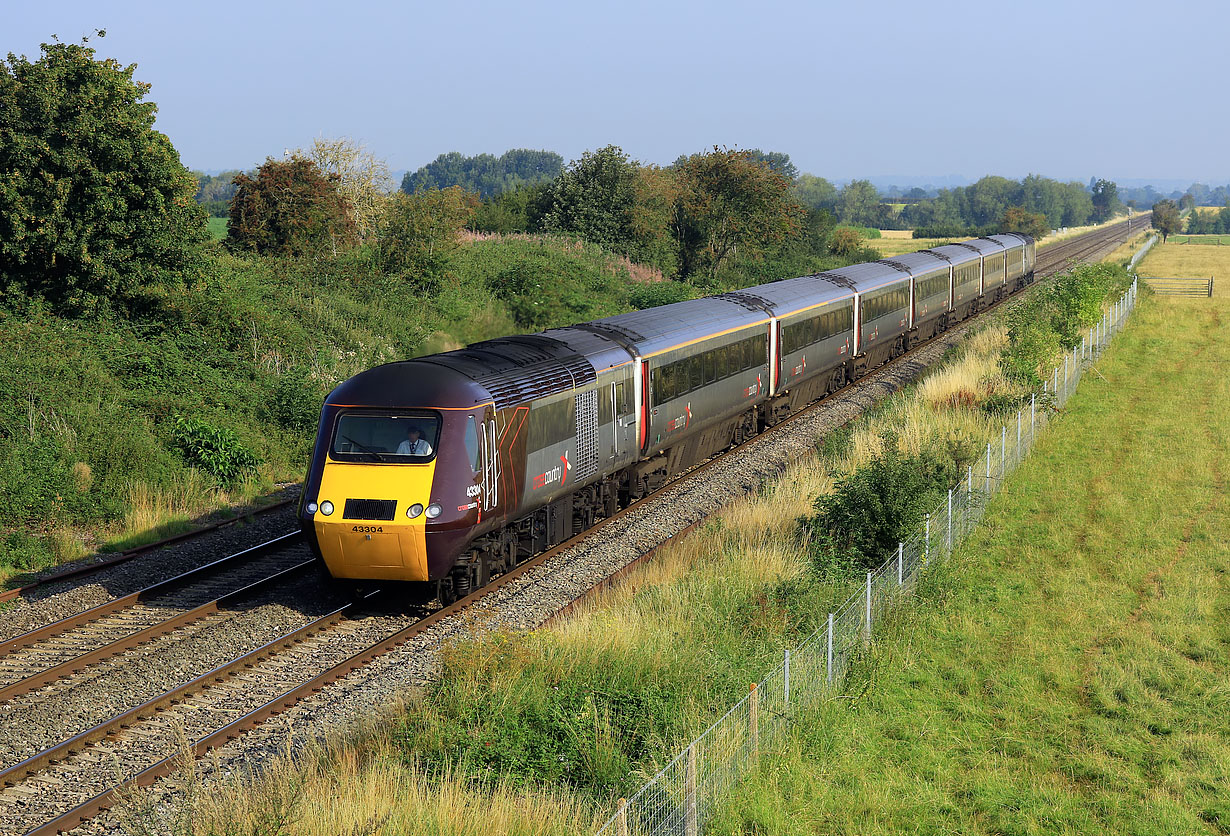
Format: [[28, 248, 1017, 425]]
[[0, 0, 1230, 184]]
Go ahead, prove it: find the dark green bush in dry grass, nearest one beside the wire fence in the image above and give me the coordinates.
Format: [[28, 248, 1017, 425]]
[[798, 433, 980, 577]]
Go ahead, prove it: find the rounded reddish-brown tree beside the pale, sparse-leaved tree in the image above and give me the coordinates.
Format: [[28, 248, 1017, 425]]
[[226, 155, 355, 257]]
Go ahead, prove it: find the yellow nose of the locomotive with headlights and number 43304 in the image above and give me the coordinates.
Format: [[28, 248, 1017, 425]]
[[312, 460, 435, 580]]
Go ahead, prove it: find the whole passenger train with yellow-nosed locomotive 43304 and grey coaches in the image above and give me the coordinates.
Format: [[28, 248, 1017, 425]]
[[299, 234, 1034, 604]]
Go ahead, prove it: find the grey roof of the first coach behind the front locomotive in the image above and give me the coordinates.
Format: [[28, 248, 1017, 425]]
[[585, 295, 769, 357]]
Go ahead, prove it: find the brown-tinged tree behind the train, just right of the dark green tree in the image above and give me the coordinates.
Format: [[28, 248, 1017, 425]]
[[674, 148, 804, 279]]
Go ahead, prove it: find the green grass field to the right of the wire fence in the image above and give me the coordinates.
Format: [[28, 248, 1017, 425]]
[[708, 290, 1230, 835]]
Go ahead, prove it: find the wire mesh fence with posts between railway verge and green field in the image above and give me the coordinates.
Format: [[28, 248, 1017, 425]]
[[598, 282, 1137, 836]]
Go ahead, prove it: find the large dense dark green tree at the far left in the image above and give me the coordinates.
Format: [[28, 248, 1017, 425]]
[[0, 32, 205, 314]]
